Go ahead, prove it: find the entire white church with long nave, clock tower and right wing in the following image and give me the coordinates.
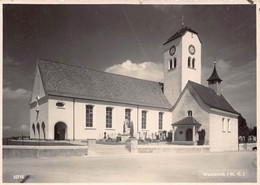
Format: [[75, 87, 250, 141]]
[[30, 27, 239, 151]]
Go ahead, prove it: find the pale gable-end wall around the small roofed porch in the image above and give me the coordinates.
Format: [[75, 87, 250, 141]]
[[172, 90, 209, 144]]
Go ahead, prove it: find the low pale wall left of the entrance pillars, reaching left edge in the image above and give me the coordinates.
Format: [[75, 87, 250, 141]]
[[3, 146, 88, 159]]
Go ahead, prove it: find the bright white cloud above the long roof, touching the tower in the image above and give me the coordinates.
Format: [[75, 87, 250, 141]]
[[105, 60, 163, 82]]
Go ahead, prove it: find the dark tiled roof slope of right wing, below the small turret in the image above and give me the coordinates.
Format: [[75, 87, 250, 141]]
[[188, 81, 239, 114]]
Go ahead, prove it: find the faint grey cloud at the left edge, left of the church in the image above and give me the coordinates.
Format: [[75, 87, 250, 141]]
[[3, 87, 31, 100]]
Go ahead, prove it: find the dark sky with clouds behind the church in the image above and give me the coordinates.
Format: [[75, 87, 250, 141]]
[[3, 5, 256, 137]]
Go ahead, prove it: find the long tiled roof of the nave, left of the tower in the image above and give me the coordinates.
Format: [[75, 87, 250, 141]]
[[38, 60, 171, 109]]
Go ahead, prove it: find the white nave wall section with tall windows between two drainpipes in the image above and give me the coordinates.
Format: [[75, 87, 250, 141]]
[[75, 99, 137, 139]]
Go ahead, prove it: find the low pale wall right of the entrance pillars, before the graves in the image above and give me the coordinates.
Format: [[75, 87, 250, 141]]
[[138, 145, 209, 153]]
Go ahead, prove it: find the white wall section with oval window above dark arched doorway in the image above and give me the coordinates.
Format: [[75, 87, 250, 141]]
[[48, 96, 73, 139]]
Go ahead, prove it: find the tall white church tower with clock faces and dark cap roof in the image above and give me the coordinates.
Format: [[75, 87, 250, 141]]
[[163, 26, 201, 105]]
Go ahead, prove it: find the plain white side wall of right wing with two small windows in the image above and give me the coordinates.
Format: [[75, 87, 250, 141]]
[[210, 113, 238, 151]]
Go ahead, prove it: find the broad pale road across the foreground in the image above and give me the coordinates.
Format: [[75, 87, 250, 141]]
[[3, 151, 256, 183]]
